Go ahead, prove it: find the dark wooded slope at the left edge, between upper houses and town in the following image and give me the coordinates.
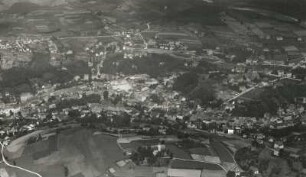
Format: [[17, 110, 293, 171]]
[[0, 53, 89, 95]]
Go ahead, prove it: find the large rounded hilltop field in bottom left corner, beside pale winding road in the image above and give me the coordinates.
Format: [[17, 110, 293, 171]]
[[4, 129, 124, 177]]
